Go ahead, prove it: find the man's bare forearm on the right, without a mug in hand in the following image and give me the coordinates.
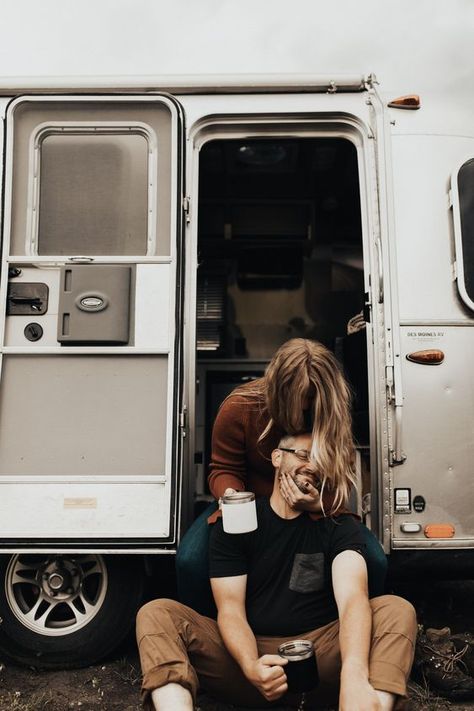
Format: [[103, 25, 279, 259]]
[[332, 550, 381, 711]]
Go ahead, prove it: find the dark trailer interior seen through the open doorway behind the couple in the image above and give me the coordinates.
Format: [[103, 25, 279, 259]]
[[194, 137, 370, 513]]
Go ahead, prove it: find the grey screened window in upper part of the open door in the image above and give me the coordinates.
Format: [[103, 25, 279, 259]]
[[37, 131, 149, 255]]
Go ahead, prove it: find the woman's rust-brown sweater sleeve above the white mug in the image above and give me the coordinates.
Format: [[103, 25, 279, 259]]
[[209, 395, 248, 499]]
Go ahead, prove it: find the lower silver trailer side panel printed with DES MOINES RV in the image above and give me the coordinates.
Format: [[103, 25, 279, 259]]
[[393, 326, 474, 547]]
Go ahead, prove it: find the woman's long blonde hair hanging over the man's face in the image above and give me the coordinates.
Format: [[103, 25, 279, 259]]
[[234, 338, 355, 514]]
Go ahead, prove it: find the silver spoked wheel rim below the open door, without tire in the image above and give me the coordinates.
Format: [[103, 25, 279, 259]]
[[5, 554, 107, 637]]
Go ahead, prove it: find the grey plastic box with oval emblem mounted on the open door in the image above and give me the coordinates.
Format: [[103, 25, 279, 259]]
[[58, 265, 131, 344]]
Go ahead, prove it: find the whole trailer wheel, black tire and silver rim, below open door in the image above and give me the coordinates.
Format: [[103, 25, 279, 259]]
[[0, 553, 144, 669]]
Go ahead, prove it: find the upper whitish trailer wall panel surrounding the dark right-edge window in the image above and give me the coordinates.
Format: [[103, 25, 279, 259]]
[[393, 134, 474, 324]]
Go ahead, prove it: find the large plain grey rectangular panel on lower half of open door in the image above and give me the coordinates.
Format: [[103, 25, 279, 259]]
[[0, 355, 171, 476]]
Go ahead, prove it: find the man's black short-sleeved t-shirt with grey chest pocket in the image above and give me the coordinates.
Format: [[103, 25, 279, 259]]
[[209, 498, 365, 637]]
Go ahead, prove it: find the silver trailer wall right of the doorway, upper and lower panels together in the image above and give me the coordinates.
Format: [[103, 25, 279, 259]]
[[390, 102, 474, 549]]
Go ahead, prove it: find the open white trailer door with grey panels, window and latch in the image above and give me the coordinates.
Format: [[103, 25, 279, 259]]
[[0, 95, 182, 547]]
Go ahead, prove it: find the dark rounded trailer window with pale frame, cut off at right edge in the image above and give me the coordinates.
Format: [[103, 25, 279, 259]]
[[451, 158, 474, 309]]
